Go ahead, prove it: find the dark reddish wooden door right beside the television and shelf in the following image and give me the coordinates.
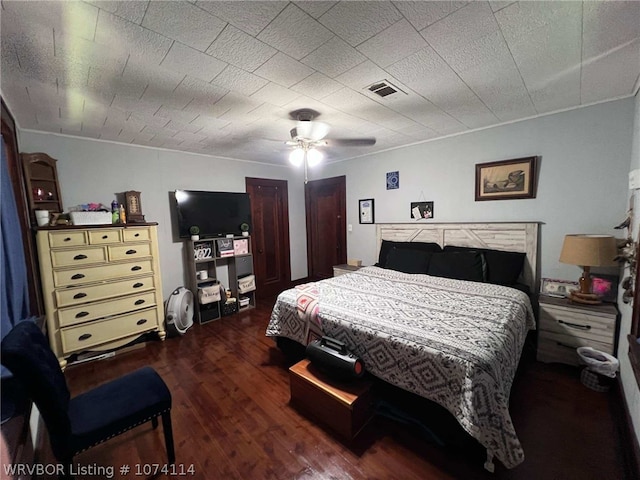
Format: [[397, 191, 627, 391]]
[[246, 178, 291, 298]]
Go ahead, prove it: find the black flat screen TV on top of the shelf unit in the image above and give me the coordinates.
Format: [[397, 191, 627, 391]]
[[175, 190, 251, 238]]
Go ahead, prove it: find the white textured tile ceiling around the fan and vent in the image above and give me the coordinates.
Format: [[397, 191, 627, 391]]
[[0, 0, 640, 164]]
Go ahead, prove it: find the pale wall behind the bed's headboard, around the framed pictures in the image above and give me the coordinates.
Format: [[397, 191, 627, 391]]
[[322, 98, 634, 280]]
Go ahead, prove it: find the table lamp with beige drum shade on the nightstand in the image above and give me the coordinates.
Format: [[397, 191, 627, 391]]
[[560, 235, 618, 305]]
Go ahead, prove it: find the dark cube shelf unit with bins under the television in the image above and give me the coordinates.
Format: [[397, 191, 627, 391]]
[[186, 236, 256, 324]]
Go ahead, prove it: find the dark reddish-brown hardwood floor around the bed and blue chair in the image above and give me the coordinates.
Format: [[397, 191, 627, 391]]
[[55, 302, 631, 480]]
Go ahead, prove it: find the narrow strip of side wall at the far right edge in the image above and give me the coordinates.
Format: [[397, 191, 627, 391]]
[[618, 93, 640, 450]]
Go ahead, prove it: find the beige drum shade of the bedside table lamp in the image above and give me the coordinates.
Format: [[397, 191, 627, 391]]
[[560, 235, 618, 267]]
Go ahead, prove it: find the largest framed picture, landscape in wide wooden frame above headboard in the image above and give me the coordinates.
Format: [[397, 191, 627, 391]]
[[476, 157, 537, 202]]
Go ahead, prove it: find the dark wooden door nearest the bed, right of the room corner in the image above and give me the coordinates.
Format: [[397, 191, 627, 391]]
[[305, 176, 347, 280]]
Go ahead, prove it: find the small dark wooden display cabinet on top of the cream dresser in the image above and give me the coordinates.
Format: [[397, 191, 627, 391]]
[[20, 153, 63, 226]]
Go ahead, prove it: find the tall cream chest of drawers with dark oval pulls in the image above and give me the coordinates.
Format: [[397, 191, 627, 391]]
[[36, 224, 166, 367]]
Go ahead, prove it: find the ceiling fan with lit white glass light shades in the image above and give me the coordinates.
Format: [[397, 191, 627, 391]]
[[286, 108, 376, 184]]
